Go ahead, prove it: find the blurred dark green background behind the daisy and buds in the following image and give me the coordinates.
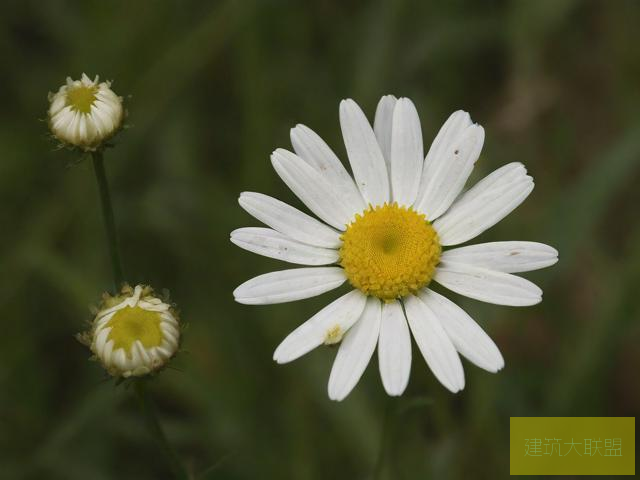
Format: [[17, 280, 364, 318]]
[[0, 0, 640, 480]]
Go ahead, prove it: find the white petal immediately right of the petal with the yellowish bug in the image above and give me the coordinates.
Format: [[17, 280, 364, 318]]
[[329, 297, 382, 401]]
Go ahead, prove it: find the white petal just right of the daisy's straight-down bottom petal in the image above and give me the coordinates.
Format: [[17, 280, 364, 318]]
[[404, 295, 464, 393]]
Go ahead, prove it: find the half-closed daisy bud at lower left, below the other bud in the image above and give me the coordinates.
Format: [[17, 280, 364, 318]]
[[86, 285, 180, 378]]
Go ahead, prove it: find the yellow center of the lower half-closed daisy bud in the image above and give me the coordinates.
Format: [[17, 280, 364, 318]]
[[107, 307, 162, 353]]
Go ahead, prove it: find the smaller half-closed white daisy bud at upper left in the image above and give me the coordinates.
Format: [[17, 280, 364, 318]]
[[49, 73, 124, 151]]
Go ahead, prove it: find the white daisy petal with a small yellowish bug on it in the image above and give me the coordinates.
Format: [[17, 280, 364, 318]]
[[273, 290, 367, 363]]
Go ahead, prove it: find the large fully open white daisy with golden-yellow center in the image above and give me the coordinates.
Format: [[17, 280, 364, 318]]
[[231, 95, 558, 400]]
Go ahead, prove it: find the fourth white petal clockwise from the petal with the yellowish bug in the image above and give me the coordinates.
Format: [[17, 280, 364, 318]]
[[271, 148, 354, 230]]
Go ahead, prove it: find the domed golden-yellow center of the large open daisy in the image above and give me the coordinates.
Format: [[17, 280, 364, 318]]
[[340, 203, 441, 302]]
